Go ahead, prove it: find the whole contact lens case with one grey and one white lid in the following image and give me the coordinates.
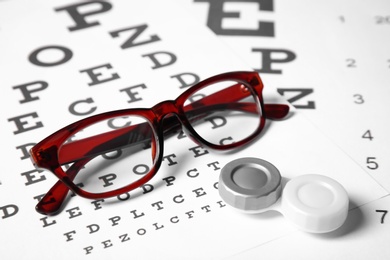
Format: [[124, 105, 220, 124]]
[[218, 158, 349, 233]]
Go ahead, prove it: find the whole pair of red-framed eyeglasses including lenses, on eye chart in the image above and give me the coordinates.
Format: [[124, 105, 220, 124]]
[[30, 72, 289, 215]]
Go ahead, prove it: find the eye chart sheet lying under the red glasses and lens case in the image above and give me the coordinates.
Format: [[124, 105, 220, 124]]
[[0, 1, 389, 259]]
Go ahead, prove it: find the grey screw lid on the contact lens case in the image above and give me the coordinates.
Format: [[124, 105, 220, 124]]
[[218, 158, 282, 211]]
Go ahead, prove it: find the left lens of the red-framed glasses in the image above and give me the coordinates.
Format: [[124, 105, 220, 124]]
[[59, 116, 156, 193]]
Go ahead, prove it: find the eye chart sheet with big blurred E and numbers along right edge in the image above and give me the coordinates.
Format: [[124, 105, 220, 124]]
[[177, 0, 390, 258]]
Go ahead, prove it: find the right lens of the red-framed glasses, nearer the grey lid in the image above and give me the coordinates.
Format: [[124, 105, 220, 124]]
[[184, 81, 261, 145]]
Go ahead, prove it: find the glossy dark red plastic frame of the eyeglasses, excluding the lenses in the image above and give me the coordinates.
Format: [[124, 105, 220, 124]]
[[30, 71, 289, 215]]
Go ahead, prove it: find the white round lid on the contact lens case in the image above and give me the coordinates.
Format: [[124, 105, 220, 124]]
[[280, 174, 349, 233]]
